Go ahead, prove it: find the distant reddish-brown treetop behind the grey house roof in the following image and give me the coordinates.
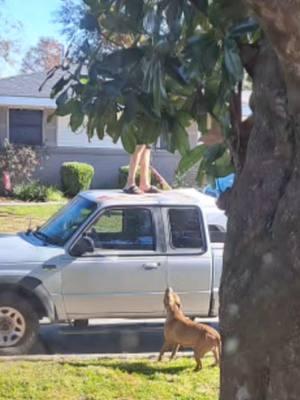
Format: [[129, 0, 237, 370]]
[[21, 38, 63, 74]]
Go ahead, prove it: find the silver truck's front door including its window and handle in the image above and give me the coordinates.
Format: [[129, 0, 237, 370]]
[[62, 207, 166, 318]]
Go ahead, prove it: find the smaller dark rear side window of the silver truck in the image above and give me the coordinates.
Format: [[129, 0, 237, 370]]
[[169, 207, 204, 249]]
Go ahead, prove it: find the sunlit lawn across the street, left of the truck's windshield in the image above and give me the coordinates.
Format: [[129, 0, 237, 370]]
[[0, 204, 61, 233]]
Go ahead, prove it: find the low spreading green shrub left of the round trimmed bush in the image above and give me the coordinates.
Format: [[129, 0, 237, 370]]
[[13, 181, 63, 202]]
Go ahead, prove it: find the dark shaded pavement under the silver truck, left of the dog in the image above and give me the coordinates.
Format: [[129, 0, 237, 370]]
[[32, 319, 218, 354]]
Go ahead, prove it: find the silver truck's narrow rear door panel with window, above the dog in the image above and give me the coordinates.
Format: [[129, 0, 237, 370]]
[[162, 206, 212, 316]]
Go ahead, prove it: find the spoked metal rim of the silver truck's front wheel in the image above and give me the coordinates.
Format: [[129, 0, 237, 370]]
[[0, 307, 26, 347]]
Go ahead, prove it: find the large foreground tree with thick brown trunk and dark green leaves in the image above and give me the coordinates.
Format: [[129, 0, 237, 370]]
[[49, 0, 300, 400]]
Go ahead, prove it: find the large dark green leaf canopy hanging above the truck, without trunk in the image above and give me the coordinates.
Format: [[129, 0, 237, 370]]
[[53, 0, 259, 180]]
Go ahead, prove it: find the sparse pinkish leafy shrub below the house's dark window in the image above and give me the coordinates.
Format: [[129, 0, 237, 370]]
[[0, 141, 40, 192]]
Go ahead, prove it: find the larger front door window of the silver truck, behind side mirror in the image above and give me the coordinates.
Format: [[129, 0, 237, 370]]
[[87, 208, 155, 251]]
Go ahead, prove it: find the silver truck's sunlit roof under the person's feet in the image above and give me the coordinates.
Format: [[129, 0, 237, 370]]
[[81, 189, 216, 208]]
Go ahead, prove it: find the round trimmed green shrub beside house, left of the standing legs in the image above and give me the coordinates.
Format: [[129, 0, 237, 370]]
[[61, 162, 95, 196]]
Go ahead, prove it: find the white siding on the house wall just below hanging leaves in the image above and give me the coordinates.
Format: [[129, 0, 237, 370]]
[[57, 117, 122, 149]]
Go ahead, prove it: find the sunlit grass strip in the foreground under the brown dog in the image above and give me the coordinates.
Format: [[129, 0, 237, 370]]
[[0, 357, 219, 400]]
